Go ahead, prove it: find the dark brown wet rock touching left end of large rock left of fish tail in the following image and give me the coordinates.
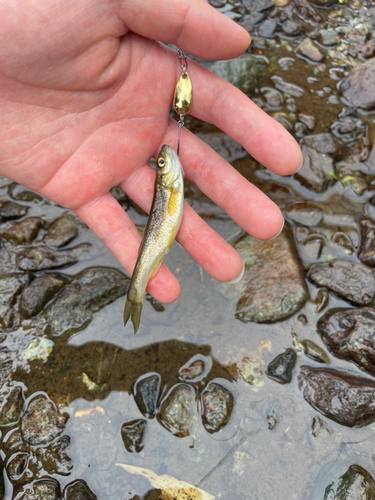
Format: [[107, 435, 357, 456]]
[[19, 273, 70, 318]]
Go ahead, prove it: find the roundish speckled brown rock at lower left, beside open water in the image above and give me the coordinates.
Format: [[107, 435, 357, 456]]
[[21, 395, 68, 446]]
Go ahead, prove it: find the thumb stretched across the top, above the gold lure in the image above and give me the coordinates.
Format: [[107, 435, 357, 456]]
[[120, 0, 250, 59]]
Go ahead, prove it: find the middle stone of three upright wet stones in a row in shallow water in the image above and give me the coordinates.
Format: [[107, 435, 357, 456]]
[[157, 384, 195, 437]]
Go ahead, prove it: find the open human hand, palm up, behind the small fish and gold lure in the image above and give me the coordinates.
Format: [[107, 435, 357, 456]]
[[0, 0, 302, 302]]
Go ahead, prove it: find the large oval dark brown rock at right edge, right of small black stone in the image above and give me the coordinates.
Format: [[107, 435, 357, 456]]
[[298, 366, 375, 427]]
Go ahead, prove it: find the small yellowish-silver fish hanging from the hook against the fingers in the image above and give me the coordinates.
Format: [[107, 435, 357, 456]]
[[124, 144, 184, 333]]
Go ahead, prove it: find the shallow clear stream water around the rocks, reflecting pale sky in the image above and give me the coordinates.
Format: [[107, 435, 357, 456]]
[[0, 0, 375, 500]]
